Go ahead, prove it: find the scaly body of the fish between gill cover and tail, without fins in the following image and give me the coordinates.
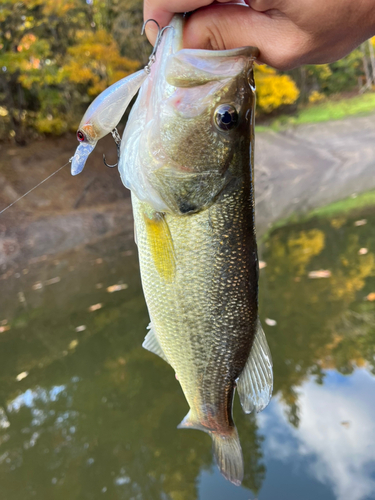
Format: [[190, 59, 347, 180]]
[[132, 172, 257, 433]]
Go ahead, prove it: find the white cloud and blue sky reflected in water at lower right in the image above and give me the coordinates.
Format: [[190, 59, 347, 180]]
[[259, 370, 375, 500]]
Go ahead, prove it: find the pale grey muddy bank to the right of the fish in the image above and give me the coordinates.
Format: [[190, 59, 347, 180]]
[[255, 114, 375, 229]]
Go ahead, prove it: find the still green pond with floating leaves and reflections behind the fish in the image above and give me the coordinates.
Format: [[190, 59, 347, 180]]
[[0, 196, 375, 500]]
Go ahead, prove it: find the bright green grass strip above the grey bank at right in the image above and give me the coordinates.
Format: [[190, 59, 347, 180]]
[[255, 92, 375, 132]]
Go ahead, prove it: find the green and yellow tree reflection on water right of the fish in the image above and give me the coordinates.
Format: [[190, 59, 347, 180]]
[[260, 211, 375, 425]]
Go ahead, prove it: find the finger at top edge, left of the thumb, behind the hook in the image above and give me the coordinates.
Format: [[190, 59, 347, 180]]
[[143, 0, 214, 45]]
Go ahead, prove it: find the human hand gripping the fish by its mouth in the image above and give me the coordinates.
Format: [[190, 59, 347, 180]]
[[144, 0, 375, 70]]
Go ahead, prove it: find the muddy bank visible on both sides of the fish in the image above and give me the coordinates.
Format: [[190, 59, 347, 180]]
[[0, 115, 375, 271]]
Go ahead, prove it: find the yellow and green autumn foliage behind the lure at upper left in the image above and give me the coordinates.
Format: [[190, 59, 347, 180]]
[[0, 0, 139, 143]]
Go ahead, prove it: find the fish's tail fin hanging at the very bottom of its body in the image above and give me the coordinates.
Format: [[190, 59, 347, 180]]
[[211, 428, 243, 486]]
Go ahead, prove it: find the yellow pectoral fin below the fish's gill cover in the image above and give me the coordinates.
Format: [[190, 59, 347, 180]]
[[143, 212, 176, 283]]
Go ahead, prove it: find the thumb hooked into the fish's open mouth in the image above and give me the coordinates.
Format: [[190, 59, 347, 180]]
[[184, 4, 307, 69]]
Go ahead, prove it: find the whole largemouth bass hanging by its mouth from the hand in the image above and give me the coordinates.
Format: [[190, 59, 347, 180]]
[[71, 15, 273, 485]]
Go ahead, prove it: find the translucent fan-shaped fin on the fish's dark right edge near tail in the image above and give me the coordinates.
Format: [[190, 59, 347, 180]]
[[237, 319, 273, 413]]
